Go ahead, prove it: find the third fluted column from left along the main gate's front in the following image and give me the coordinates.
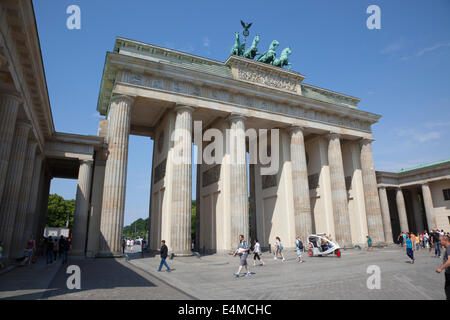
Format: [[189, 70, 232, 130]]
[[229, 114, 249, 249]]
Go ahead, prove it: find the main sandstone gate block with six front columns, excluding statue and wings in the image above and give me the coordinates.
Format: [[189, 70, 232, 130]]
[[87, 38, 385, 255]]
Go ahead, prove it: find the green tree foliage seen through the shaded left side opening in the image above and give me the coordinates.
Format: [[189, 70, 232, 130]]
[[45, 193, 75, 230]]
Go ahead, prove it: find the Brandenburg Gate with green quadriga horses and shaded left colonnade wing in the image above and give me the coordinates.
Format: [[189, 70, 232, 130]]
[[0, 1, 392, 259]]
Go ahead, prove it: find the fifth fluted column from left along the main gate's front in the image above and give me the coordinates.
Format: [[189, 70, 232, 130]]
[[328, 133, 352, 246]]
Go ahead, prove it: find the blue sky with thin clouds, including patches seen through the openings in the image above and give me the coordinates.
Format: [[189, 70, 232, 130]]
[[33, 0, 450, 224]]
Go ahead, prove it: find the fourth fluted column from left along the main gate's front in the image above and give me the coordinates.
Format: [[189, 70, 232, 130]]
[[290, 127, 312, 239]]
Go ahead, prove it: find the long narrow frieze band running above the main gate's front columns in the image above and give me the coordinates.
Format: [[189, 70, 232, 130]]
[[121, 71, 370, 132]]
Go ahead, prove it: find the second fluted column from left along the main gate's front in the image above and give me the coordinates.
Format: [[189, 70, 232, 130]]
[[170, 106, 192, 256]]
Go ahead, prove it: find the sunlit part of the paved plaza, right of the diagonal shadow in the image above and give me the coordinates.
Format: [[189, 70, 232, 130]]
[[130, 247, 445, 300]]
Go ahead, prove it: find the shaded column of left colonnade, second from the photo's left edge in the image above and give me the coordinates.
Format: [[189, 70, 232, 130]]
[[0, 122, 31, 258]]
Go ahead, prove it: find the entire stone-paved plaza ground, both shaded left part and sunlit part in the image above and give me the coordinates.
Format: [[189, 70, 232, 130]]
[[0, 248, 445, 300]]
